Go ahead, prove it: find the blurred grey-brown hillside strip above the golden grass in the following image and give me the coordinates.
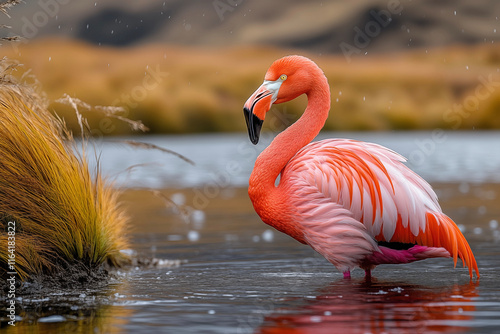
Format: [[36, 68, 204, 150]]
[[2, 0, 500, 54]]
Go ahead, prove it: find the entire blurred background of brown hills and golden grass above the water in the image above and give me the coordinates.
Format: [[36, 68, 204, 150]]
[[0, 0, 500, 135]]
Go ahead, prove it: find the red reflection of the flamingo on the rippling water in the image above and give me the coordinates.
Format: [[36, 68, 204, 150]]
[[257, 279, 478, 334]]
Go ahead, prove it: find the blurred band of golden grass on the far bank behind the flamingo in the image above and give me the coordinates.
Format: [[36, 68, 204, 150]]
[[2, 39, 500, 135]]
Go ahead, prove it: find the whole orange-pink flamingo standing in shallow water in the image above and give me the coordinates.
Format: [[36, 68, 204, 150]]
[[243, 56, 479, 280]]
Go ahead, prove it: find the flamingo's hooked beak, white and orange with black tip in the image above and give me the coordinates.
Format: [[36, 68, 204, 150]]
[[243, 80, 279, 145]]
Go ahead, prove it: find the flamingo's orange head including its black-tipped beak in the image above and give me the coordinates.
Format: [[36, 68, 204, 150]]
[[243, 56, 322, 144]]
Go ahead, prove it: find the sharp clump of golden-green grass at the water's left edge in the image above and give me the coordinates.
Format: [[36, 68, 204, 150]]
[[0, 62, 127, 280]]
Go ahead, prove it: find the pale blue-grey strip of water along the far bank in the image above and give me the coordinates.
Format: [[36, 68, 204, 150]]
[[89, 131, 500, 188]]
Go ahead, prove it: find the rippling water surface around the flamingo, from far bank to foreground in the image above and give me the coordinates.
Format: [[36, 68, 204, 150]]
[[2, 132, 500, 333]]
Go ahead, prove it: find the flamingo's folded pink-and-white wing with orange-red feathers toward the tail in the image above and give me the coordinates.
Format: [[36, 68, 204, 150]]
[[280, 139, 478, 277]]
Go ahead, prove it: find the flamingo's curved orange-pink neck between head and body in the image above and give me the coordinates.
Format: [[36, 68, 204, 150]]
[[249, 73, 330, 196]]
